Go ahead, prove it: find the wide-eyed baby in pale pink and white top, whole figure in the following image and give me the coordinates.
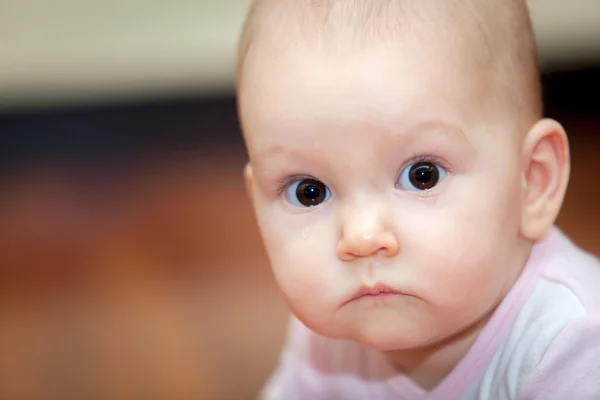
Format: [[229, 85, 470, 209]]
[[237, 0, 600, 400]]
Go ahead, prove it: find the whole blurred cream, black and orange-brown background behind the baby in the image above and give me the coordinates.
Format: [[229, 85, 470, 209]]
[[0, 0, 600, 400]]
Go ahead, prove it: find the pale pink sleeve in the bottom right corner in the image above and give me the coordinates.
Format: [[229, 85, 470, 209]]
[[519, 316, 600, 400]]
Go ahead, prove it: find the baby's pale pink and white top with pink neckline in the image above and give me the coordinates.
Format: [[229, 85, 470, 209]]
[[261, 228, 600, 400]]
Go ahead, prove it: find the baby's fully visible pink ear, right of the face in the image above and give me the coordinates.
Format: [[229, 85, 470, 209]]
[[521, 119, 570, 240]]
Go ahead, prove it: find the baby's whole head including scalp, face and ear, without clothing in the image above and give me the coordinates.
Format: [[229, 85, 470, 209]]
[[238, 0, 568, 350]]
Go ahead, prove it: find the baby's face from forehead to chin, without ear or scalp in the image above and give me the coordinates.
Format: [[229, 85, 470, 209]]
[[239, 39, 523, 350]]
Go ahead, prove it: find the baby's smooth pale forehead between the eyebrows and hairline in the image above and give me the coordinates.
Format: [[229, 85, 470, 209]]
[[238, 40, 496, 152]]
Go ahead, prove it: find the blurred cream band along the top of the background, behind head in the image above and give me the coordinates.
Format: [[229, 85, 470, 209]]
[[0, 0, 600, 108]]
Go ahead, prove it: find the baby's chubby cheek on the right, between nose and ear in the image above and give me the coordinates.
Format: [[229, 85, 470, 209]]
[[403, 173, 519, 323]]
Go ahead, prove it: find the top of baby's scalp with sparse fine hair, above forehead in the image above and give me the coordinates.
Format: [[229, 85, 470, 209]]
[[237, 0, 542, 122]]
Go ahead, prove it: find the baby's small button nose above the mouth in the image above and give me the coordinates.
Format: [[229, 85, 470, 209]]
[[336, 203, 399, 261]]
